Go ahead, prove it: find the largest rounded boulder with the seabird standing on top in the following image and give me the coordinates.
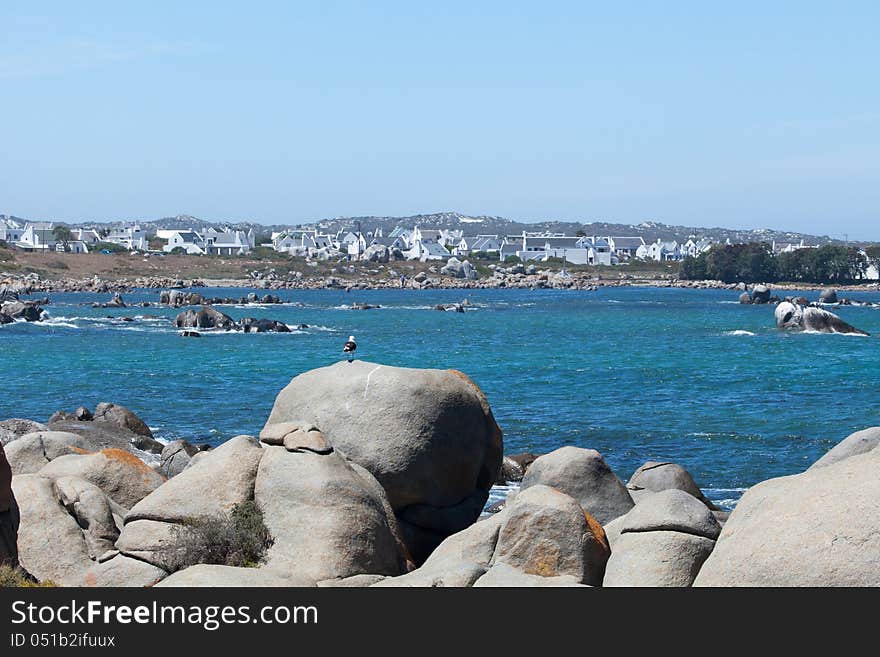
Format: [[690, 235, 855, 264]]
[[261, 361, 502, 562]]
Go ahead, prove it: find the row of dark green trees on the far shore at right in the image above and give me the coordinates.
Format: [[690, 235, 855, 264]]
[[680, 242, 876, 285]]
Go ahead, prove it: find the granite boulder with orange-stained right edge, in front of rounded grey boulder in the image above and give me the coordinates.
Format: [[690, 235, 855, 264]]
[[492, 482, 610, 586]]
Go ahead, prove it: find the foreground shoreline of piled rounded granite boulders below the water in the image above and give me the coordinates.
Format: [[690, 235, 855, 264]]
[[0, 361, 880, 587]]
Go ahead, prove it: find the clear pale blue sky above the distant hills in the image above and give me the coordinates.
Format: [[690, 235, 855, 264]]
[[0, 0, 880, 240]]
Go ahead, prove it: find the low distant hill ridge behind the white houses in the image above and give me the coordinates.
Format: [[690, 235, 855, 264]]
[[0, 212, 868, 245]]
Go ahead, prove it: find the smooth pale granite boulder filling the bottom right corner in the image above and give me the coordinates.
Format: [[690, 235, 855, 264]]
[[694, 449, 880, 587]]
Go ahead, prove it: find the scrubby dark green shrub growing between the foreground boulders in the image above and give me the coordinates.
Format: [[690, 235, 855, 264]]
[[171, 500, 274, 569]]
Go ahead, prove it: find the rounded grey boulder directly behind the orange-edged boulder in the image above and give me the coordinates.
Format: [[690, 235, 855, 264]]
[[521, 446, 633, 525]]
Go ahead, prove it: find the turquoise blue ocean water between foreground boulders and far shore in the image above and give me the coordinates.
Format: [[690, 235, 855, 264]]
[[0, 288, 880, 507]]
